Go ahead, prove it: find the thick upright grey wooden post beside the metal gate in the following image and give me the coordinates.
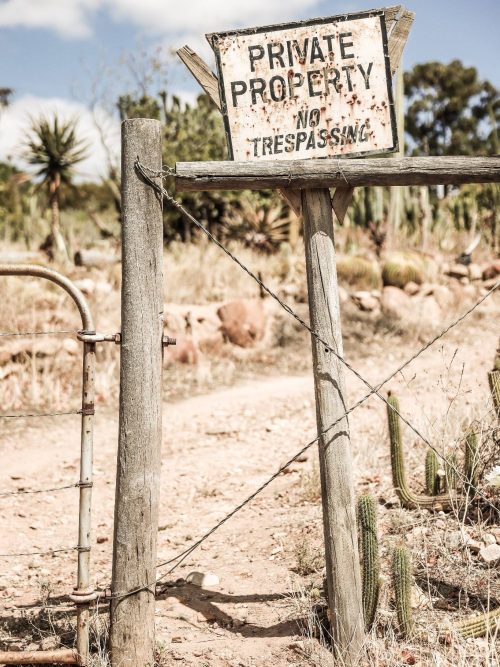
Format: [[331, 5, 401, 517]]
[[110, 119, 163, 667]]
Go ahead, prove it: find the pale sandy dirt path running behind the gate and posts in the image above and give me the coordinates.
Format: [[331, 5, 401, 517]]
[[0, 310, 498, 667]]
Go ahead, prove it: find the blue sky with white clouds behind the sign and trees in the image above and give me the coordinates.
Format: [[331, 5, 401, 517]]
[[0, 0, 500, 180]]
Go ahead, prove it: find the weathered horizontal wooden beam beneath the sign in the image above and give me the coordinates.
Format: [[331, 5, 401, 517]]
[[175, 156, 500, 192]]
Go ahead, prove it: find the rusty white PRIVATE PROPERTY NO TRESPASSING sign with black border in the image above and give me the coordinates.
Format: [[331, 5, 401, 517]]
[[207, 9, 398, 161]]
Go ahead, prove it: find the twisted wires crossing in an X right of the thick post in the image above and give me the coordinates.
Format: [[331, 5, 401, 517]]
[[105, 158, 500, 599]]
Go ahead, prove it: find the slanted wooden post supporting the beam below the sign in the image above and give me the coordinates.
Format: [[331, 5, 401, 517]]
[[302, 189, 364, 667]]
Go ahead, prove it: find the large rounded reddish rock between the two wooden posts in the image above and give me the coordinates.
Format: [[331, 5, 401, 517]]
[[217, 299, 266, 347]]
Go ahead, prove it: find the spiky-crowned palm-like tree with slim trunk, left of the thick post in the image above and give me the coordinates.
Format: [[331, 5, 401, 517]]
[[26, 115, 87, 260]]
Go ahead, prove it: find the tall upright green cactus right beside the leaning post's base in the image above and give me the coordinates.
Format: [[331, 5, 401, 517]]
[[357, 495, 380, 631]]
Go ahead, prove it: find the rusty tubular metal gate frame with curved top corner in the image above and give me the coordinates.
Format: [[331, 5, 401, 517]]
[[0, 264, 98, 665]]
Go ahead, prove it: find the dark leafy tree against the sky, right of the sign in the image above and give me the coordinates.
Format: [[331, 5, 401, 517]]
[[404, 60, 500, 155]]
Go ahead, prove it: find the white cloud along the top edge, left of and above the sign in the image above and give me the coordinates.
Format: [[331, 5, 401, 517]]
[[0, 0, 321, 39]]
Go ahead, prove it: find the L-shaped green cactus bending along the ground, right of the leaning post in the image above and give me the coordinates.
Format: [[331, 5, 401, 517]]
[[387, 392, 455, 510]]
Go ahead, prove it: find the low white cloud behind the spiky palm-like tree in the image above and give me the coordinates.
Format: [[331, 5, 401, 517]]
[[0, 95, 120, 181]]
